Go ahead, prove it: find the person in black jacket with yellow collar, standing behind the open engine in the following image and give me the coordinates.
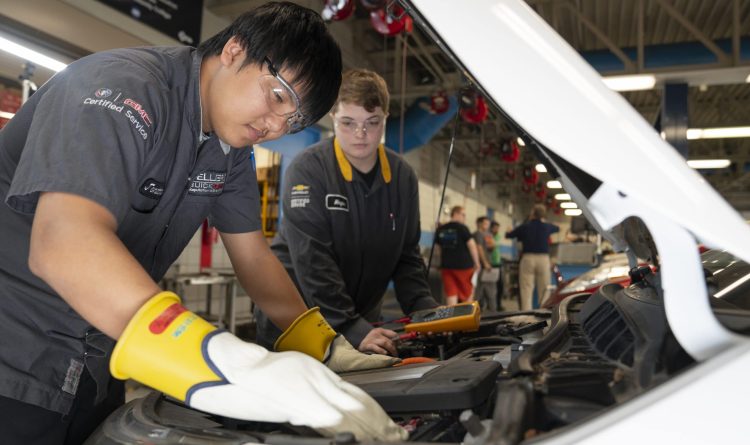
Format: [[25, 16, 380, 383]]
[[256, 69, 438, 355]]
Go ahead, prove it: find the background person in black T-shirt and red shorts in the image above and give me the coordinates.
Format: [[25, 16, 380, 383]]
[[435, 206, 481, 305]]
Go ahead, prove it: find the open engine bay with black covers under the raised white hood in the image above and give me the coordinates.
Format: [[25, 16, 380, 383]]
[[86, 260, 728, 445]]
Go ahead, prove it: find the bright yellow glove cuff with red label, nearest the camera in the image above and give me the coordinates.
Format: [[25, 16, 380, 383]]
[[109, 292, 222, 401]]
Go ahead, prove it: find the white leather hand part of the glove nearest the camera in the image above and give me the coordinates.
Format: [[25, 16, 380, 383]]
[[189, 332, 408, 441]]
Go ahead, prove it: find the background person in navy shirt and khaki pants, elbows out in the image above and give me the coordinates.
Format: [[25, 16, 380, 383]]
[[505, 204, 560, 311]]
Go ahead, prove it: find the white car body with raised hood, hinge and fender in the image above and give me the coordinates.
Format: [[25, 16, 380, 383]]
[[409, 0, 750, 443]]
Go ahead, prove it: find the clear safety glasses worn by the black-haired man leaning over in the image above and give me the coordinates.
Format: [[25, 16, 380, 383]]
[[259, 57, 305, 133]]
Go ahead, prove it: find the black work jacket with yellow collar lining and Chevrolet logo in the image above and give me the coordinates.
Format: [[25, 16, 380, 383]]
[[256, 139, 437, 347]]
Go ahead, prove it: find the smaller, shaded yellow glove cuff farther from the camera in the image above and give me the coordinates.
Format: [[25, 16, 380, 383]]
[[273, 307, 336, 362]]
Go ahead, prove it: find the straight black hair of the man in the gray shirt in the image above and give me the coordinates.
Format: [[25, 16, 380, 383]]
[[198, 2, 342, 126]]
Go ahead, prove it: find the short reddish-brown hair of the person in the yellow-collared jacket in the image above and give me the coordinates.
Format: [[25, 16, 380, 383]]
[[333, 68, 390, 114]]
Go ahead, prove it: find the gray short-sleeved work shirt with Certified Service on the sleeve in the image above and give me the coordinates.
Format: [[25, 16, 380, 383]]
[[0, 47, 260, 413]]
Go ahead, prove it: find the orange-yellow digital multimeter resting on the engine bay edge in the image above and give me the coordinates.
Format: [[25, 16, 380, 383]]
[[404, 301, 480, 332]]
